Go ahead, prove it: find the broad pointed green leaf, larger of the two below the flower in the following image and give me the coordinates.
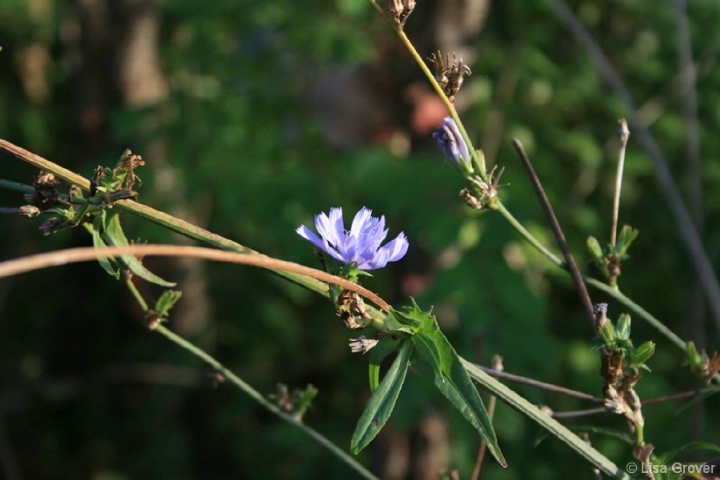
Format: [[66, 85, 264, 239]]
[[411, 306, 507, 466]]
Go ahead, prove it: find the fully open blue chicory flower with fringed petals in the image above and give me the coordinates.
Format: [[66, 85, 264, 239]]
[[296, 207, 408, 270]]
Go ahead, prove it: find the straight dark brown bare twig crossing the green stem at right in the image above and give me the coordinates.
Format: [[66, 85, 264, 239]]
[[512, 138, 595, 326]]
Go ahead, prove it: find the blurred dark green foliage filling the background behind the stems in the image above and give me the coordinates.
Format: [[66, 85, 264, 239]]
[[0, 0, 720, 479]]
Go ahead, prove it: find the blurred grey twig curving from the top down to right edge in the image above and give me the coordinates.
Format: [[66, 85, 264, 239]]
[[547, 0, 720, 335]]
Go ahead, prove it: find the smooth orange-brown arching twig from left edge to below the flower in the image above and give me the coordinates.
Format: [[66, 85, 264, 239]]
[[0, 245, 390, 312]]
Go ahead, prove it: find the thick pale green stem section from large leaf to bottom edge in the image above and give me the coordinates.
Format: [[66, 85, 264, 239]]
[[461, 359, 628, 479]]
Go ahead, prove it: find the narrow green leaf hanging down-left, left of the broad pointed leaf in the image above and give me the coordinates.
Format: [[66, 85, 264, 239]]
[[350, 340, 413, 454]]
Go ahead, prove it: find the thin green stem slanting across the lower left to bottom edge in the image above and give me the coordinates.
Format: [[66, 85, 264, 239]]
[[155, 325, 378, 480]]
